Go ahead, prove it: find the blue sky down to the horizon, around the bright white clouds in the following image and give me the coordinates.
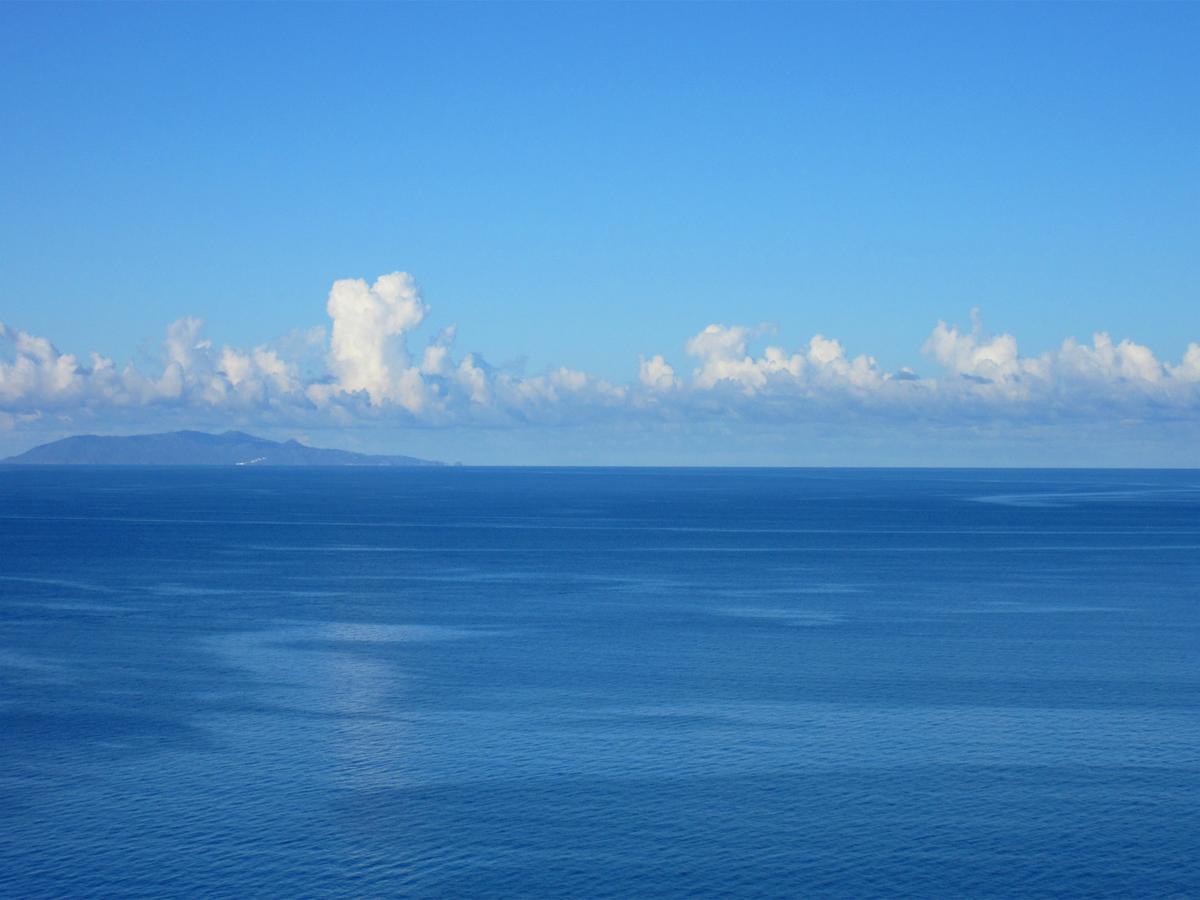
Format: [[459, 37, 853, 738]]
[[0, 4, 1200, 464]]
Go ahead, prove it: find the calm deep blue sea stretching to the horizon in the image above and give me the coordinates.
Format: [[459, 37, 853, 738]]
[[0, 467, 1200, 898]]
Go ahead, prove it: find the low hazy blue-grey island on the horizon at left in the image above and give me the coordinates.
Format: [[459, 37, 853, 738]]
[[0, 431, 442, 466]]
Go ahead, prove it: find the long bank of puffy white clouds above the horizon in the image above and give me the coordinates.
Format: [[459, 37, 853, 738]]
[[0, 271, 1200, 428]]
